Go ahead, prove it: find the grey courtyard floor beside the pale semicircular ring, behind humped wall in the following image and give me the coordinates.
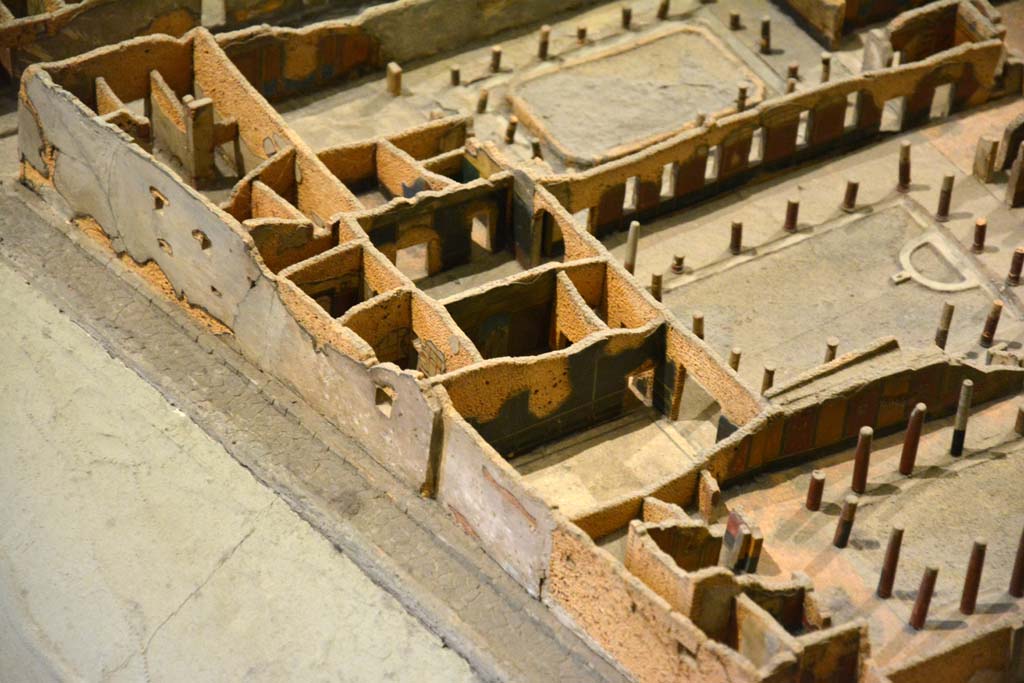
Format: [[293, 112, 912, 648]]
[[666, 207, 990, 378]]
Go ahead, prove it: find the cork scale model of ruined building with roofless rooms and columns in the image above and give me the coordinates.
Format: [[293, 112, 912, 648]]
[[8, 0, 1024, 683]]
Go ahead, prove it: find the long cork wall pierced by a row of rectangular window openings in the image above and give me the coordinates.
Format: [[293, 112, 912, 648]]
[[542, 39, 1004, 236]]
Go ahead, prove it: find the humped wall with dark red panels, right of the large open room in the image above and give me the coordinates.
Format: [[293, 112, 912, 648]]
[[573, 340, 1024, 538]]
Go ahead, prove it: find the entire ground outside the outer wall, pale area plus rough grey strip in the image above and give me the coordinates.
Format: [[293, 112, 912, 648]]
[[0, 179, 626, 683]]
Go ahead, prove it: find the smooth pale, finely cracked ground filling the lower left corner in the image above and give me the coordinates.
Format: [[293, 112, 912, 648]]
[[0, 260, 474, 681]]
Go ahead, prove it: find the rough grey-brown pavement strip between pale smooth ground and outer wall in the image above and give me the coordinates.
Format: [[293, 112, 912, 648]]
[[0, 180, 625, 681]]
